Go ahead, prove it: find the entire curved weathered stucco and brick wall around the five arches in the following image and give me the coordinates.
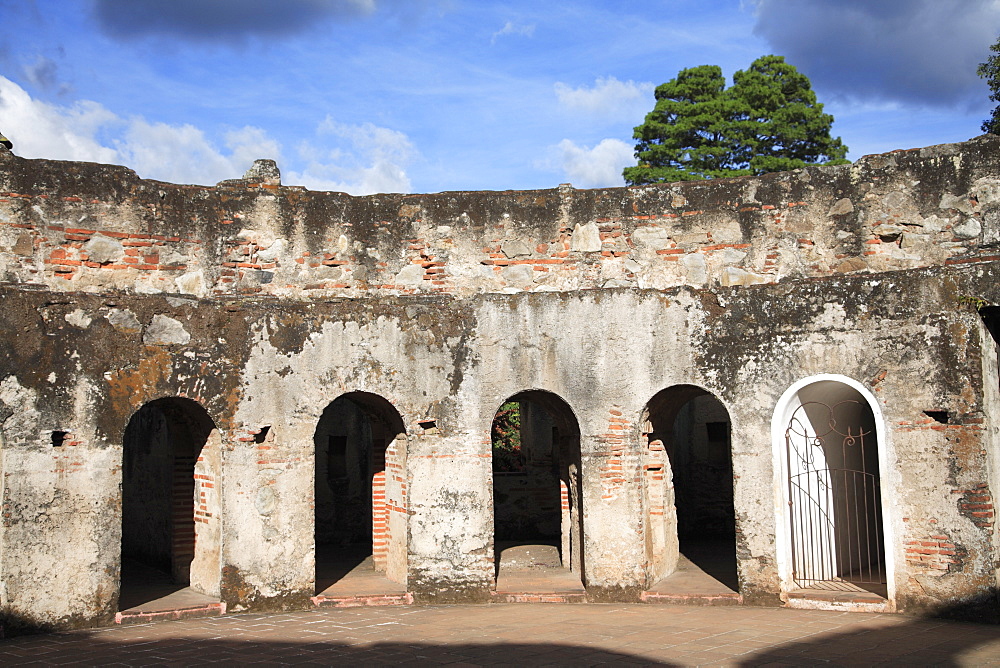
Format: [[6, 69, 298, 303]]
[[0, 138, 1000, 628]]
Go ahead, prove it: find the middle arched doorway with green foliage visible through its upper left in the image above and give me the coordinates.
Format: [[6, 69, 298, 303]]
[[491, 390, 584, 592]]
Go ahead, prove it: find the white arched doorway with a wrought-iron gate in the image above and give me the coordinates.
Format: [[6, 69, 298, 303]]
[[776, 379, 888, 597]]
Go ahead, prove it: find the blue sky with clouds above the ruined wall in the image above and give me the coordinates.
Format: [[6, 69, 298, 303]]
[[0, 0, 1000, 194]]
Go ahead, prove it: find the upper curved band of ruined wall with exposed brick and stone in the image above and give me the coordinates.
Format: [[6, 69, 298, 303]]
[[0, 135, 1000, 298]]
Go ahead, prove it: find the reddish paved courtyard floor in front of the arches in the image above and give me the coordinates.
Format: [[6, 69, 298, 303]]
[[0, 604, 1000, 666]]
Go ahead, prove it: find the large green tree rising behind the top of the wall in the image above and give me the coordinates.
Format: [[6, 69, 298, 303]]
[[624, 56, 847, 185]]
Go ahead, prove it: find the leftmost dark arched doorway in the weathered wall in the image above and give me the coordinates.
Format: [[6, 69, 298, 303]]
[[119, 397, 221, 611]]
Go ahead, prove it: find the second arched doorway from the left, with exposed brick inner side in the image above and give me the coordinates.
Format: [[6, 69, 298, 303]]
[[313, 392, 407, 595]]
